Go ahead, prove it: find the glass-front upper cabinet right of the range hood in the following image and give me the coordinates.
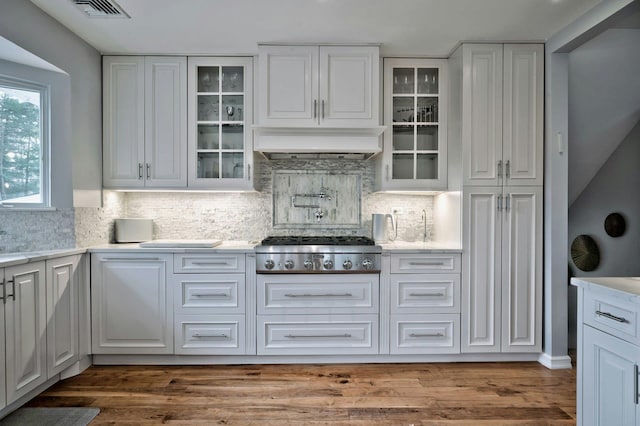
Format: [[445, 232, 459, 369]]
[[380, 58, 447, 191]]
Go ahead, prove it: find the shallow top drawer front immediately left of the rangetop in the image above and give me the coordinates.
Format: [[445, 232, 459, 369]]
[[173, 253, 245, 274]]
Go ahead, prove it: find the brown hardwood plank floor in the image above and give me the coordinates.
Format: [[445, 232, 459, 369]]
[[28, 362, 576, 426]]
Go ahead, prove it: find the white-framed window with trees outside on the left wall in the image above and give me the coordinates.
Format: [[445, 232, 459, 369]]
[[0, 76, 50, 207]]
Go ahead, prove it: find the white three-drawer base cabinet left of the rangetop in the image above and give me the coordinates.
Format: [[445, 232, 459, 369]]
[[171, 253, 247, 355]]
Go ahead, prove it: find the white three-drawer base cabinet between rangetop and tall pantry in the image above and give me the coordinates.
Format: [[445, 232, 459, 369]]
[[389, 253, 460, 355]]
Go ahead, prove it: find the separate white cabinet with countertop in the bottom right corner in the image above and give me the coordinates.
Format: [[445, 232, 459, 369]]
[[571, 277, 640, 426]]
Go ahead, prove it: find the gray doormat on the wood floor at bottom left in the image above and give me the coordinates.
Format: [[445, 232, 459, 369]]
[[0, 407, 100, 426]]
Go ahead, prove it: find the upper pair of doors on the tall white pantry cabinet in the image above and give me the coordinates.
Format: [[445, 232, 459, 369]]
[[457, 44, 544, 186]]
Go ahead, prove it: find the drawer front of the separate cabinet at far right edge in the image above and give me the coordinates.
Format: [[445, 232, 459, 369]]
[[584, 291, 640, 344]]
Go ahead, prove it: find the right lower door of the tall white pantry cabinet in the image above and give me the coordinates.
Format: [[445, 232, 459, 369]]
[[502, 187, 542, 352]]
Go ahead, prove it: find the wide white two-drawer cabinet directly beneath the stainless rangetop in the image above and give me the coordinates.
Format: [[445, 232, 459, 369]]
[[257, 274, 380, 355]]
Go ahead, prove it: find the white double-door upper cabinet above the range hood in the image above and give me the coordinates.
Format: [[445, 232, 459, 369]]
[[259, 45, 380, 128]]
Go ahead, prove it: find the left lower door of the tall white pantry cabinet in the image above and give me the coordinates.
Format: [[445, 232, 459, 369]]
[[461, 188, 502, 352]]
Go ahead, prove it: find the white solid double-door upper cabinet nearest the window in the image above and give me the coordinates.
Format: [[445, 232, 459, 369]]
[[103, 56, 187, 188]]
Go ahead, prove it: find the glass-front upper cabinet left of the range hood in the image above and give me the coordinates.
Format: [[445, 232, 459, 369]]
[[188, 57, 254, 190]]
